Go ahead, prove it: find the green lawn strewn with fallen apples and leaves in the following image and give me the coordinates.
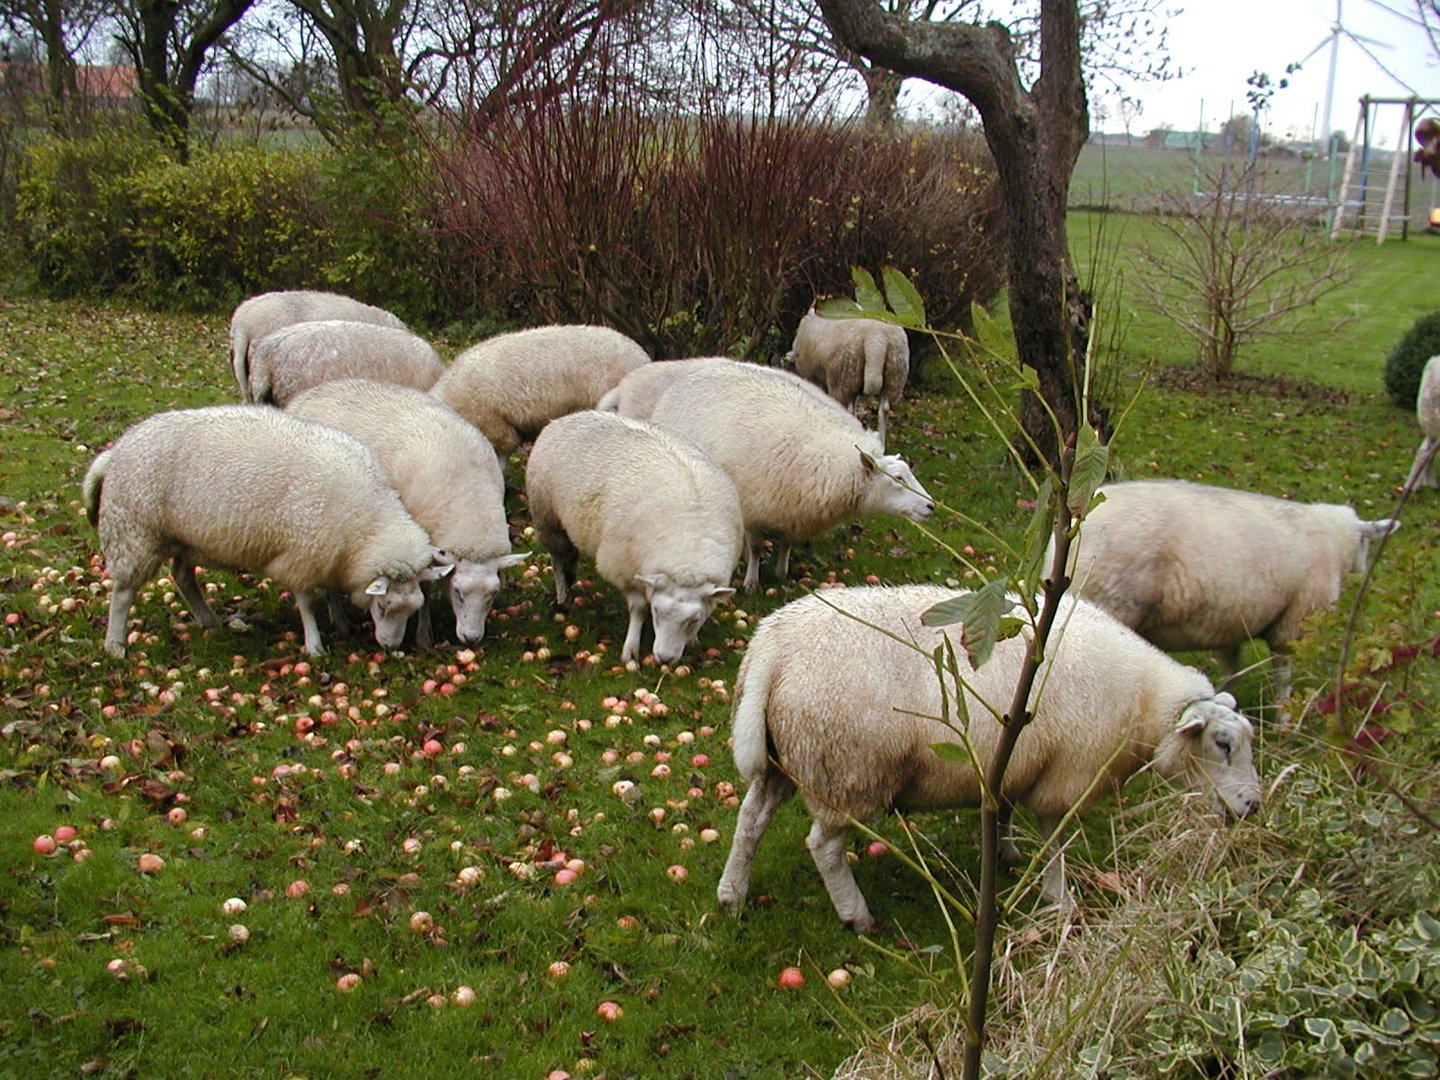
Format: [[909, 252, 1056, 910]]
[[0, 230, 1440, 1077]]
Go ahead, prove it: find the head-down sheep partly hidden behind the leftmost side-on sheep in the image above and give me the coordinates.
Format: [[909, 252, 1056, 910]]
[[285, 379, 530, 644]]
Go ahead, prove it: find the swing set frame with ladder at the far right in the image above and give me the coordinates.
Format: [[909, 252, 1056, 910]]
[[1329, 94, 1440, 243]]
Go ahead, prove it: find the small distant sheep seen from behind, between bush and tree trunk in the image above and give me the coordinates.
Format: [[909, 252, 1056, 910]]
[[791, 308, 910, 445]]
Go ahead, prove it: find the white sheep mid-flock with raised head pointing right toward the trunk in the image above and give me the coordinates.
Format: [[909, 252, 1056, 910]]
[[651, 364, 935, 592]]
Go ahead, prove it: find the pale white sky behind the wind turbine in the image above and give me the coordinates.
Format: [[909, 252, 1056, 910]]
[[1090, 0, 1440, 147]]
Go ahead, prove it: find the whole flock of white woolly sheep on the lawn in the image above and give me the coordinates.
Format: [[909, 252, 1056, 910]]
[[84, 292, 1405, 930]]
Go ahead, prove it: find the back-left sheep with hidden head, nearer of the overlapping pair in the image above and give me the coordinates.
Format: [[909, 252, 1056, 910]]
[[243, 318, 445, 409]]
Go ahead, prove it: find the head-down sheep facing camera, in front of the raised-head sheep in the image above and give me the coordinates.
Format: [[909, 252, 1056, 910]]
[[526, 410, 742, 664]]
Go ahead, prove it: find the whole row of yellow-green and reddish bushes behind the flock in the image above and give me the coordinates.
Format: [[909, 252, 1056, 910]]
[[17, 110, 1004, 347]]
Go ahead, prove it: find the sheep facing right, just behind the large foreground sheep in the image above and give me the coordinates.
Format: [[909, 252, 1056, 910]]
[[1045, 480, 1400, 697]]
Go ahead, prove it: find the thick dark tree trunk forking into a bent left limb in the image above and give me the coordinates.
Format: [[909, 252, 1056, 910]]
[[821, 0, 1089, 464]]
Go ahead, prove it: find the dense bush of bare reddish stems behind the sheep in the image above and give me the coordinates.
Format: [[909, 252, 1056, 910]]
[[428, 101, 1002, 357]]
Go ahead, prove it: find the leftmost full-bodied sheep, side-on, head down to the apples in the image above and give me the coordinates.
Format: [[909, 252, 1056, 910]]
[[84, 405, 449, 657]]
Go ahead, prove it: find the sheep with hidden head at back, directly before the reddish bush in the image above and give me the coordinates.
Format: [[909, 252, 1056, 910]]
[[431, 325, 649, 458]]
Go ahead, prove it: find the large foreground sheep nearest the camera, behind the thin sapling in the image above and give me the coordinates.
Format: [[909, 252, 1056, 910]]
[[717, 585, 1260, 932]]
